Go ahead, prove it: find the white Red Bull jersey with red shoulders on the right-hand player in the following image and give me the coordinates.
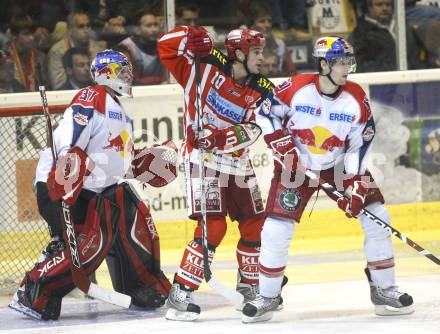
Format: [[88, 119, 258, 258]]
[[256, 74, 375, 175]]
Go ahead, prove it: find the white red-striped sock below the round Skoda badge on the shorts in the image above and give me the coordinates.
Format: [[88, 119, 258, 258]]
[[259, 216, 295, 298]]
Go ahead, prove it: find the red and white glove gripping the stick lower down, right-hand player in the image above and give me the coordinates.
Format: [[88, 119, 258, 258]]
[[337, 175, 368, 218]]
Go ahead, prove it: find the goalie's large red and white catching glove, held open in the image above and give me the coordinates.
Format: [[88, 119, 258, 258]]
[[126, 140, 178, 187]]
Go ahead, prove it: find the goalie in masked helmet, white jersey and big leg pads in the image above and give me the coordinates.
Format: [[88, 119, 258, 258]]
[[9, 50, 177, 320]]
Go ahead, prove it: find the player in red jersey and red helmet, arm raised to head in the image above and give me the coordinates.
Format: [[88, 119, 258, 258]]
[[158, 26, 272, 321]]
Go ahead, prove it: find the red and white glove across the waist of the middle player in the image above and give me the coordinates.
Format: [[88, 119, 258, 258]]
[[188, 123, 261, 154]]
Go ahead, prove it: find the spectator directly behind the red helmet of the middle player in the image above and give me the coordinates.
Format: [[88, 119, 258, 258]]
[[249, 1, 296, 76]]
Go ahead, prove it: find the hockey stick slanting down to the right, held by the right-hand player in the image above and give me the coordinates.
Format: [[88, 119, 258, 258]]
[[297, 164, 440, 265]]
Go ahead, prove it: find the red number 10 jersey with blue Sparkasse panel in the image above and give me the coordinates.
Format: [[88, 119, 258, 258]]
[[158, 26, 273, 174]]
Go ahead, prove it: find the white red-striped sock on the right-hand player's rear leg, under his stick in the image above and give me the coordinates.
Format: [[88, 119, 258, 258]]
[[359, 202, 395, 289]]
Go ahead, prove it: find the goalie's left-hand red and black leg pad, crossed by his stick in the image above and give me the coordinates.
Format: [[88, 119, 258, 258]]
[[11, 197, 119, 320]]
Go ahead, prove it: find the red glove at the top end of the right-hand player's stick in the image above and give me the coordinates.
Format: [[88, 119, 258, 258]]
[[264, 129, 299, 173]]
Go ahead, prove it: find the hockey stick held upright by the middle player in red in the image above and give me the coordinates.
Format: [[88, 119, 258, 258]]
[[194, 55, 244, 304]]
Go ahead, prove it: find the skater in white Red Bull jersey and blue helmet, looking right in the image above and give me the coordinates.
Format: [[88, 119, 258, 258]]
[[242, 37, 413, 323]]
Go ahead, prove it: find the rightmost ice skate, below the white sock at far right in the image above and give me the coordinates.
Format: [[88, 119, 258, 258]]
[[365, 269, 414, 315]]
